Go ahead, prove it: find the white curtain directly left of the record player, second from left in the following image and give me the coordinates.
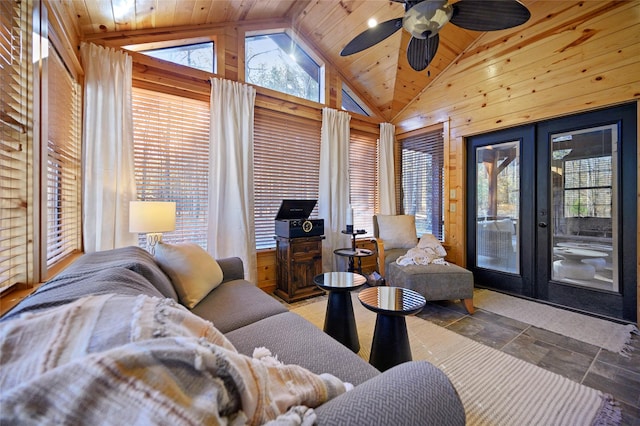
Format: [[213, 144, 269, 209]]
[[207, 78, 257, 283]]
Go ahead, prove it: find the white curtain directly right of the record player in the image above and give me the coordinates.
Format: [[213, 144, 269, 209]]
[[318, 108, 351, 272]]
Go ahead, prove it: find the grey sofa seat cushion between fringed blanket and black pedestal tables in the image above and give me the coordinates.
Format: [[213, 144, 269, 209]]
[[226, 312, 380, 385]]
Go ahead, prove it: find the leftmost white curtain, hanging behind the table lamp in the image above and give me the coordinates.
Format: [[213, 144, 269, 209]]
[[80, 43, 137, 253]]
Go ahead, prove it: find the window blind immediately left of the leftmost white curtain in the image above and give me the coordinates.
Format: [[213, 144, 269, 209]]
[[47, 49, 81, 267]]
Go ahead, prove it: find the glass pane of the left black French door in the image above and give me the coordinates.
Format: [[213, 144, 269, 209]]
[[475, 141, 520, 274]]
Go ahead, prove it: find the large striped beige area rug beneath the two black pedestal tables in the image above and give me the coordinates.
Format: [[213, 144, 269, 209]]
[[292, 294, 621, 426]]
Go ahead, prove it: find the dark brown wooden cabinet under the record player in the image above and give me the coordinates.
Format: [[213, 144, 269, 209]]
[[275, 236, 324, 302]]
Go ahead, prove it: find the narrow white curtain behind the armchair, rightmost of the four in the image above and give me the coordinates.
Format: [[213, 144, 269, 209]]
[[378, 123, 396, 214]]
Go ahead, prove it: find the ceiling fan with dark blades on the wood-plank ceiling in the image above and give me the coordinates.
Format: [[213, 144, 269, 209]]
[[340, 0, 531, 71]]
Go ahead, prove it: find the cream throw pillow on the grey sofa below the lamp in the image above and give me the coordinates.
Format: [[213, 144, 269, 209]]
[[156, 243, 222, 308]]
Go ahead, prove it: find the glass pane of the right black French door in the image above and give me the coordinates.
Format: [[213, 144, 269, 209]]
[[549, 125, 619, 292]]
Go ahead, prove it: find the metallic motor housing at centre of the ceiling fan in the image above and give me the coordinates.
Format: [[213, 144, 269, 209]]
[[402, 0, 453, 39]]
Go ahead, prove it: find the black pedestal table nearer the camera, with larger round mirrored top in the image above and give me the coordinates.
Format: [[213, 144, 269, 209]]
[[358, 287, 427, 371]]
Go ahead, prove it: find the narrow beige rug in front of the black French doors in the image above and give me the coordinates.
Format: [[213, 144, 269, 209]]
[[473, 289, 638, 354]]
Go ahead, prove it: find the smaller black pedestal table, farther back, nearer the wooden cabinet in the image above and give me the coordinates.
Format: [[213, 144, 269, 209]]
[[313, 272, 367, 352]]
